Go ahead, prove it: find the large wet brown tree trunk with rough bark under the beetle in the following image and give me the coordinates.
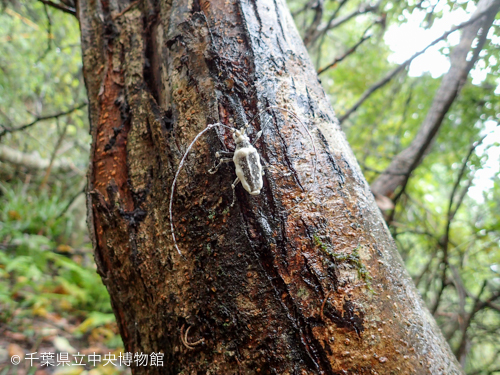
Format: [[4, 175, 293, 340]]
[[77, 0, 461, 374]]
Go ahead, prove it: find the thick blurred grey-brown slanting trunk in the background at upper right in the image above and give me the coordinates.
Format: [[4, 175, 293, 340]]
[[371, 0, 500, 197]]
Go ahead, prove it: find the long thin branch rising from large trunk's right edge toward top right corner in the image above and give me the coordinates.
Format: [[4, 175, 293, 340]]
[[339, 6, 493, 124]]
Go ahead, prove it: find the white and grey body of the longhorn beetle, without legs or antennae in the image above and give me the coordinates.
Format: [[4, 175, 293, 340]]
[[233, 129, 263, 195]]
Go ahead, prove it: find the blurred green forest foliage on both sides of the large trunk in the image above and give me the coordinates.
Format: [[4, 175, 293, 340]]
[[0, 0, 500, 374]]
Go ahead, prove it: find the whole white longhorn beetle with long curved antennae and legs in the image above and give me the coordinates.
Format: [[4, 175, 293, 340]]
[[169, 106, 317, 256]]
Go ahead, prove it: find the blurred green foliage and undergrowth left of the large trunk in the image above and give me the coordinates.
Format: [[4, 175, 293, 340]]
[[0, 1, 122, 374]]
